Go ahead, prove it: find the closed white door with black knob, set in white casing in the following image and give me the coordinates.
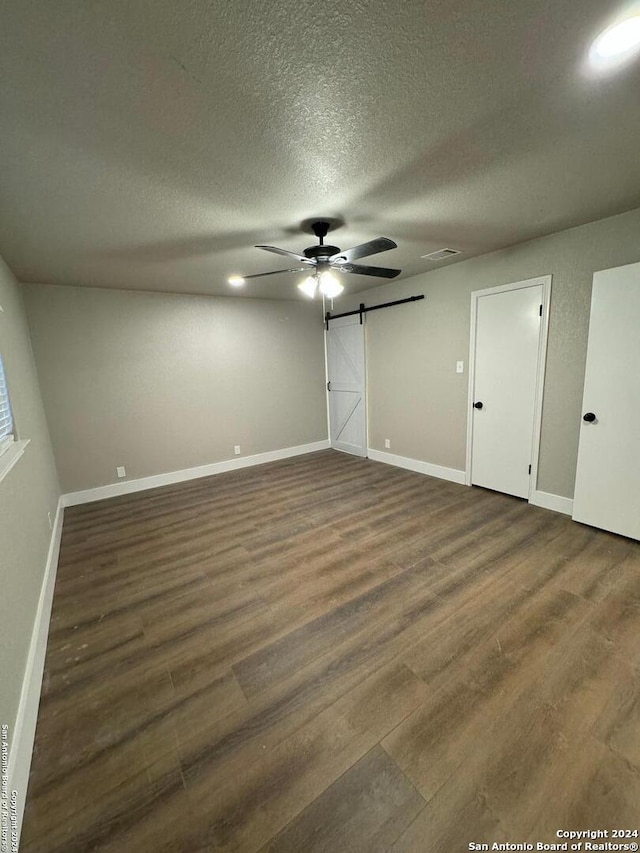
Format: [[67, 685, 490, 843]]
[[470, 283, 543, 498]]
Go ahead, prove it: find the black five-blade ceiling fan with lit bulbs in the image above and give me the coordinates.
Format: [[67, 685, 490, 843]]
[[229, 221, 402, 298]]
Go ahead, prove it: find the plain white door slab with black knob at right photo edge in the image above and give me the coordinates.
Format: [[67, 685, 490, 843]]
[[573, 264, 640, 539]]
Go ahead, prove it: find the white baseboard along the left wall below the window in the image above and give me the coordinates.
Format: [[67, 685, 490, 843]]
[[7, 492, 64, 849]]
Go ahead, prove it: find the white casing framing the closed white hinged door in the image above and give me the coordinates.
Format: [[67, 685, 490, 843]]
[[465, 275, 552, 503]]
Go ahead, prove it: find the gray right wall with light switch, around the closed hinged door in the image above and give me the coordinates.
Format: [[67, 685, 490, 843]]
[[342, 210, 640, 497]]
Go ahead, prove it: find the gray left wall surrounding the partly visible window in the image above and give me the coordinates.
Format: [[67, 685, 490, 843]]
[[0, 255, 59, 744]]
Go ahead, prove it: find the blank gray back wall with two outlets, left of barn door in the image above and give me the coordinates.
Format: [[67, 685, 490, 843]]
[[24, 285, 327, 492]]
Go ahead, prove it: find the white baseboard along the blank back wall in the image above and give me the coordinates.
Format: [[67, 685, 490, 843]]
[[62, 439, 331, 506]]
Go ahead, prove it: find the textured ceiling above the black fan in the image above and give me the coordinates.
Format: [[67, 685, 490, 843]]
[[0, 0, 640, 298]]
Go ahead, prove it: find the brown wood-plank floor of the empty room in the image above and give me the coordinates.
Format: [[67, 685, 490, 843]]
[[21, 451, 640, 853]]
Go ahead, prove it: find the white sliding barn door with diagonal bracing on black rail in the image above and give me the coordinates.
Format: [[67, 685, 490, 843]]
[[327, 315, 367, 456]]
